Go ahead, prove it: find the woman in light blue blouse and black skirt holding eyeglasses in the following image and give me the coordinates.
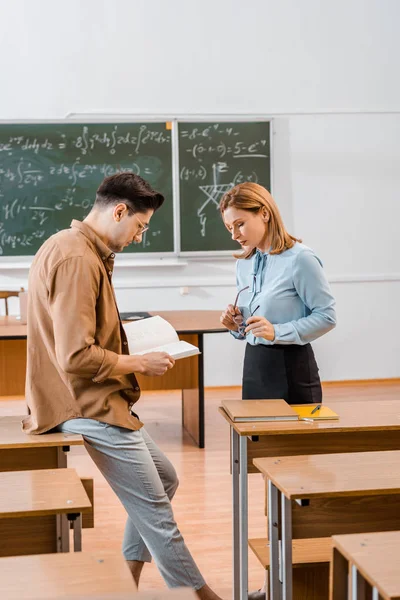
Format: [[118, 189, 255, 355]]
[[220, 183, 336, 404]]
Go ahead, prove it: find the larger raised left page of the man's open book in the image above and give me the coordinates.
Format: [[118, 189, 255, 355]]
[[123, 316, 179, 354]]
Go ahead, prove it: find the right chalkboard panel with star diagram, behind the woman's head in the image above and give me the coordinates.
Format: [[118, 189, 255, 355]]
[[178, 121, 271, 252]]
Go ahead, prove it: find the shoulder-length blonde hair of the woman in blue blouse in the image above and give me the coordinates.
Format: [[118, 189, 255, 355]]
[[219, 181, 301, 258]]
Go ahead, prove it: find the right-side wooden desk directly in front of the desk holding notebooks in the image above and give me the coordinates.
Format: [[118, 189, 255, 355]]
[[254, 451, 400, 600]]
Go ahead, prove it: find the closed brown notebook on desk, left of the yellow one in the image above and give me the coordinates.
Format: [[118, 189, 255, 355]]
[[222, 400, 299, 423]]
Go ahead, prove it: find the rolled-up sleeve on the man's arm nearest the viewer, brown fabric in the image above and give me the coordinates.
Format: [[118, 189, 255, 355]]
[[48, 256, 118, 383]]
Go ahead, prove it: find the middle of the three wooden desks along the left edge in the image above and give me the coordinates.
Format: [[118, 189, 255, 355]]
[[0, 469, 92, 556]]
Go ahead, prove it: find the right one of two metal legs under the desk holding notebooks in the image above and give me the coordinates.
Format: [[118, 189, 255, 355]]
[[239, 436, 249, 600]]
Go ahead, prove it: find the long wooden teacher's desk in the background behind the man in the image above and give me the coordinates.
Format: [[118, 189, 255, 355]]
[[0, 310, 227, 448]]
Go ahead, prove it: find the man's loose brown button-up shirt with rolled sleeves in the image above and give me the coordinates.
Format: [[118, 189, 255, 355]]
[[23, 221, 142, 433]]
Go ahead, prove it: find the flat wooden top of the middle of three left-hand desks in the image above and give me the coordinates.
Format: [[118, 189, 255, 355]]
[[0, 469, 92, 519]]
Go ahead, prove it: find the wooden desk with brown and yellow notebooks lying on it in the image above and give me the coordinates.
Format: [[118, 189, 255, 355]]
[[220, 399, 400, 600]]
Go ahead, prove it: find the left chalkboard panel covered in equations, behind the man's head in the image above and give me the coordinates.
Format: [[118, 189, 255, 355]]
[[0, 123, 174, 256]]
